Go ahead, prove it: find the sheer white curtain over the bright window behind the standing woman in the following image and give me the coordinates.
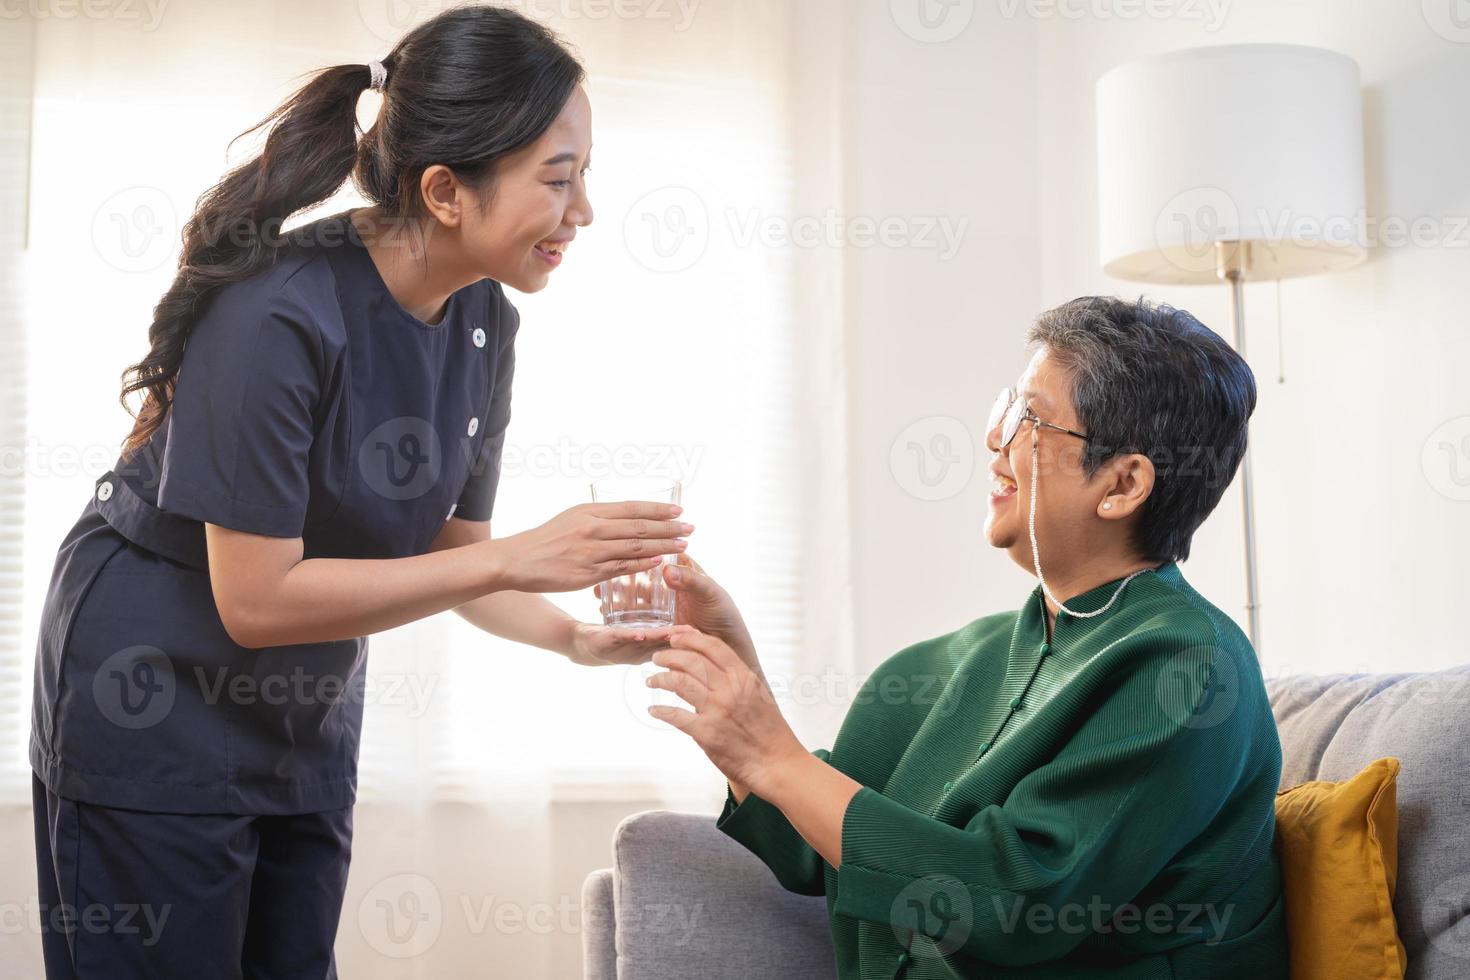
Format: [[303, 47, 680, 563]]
[[0, 0, 853, 977]]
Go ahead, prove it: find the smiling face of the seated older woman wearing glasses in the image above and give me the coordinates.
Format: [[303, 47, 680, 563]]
[[985, 347, 1113, 572]]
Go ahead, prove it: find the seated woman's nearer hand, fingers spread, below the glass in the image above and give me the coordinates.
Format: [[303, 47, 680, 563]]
[[647, 626, 807, 796]]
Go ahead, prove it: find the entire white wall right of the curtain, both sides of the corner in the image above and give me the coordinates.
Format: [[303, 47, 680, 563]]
[[847, 0, 1470, 687]]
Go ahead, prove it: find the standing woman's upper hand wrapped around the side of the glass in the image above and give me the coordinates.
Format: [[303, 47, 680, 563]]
[[485, 501, 694, 592]]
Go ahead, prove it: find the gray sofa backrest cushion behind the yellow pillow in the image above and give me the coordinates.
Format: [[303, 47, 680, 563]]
[[1267, 666, 1470, 980]]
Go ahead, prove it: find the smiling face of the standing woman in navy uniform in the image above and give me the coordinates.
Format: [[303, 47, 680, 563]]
[[462, 85, 592, 292]]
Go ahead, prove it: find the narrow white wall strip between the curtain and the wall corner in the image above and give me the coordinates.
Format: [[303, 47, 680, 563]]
[[845, 1, 1042, 671]]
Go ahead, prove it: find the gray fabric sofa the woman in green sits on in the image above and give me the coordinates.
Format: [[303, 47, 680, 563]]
[[582, 667, 1470, 980]]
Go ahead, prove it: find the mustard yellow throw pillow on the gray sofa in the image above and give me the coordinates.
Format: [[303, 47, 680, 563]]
[[1276, 758, 1408, 980]]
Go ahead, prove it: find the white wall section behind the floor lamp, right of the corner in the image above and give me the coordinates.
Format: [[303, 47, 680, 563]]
[[1038, 0, 1470, 673]]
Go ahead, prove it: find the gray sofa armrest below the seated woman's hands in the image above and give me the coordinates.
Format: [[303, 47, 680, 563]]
[[584, 810, 836, 980]]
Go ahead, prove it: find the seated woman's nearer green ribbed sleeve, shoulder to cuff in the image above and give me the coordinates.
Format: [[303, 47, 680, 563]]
[[833, 641, 1274, 965]]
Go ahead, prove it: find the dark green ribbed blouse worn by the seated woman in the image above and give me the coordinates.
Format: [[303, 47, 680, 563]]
[[717, 561, 1286, 980]]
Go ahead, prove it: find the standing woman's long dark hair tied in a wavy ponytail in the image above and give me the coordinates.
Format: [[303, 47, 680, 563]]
[[121, 6, 584, 458]]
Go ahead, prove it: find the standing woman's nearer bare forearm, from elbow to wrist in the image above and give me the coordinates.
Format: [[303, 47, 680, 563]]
[[226, 541, 500, 648]]
